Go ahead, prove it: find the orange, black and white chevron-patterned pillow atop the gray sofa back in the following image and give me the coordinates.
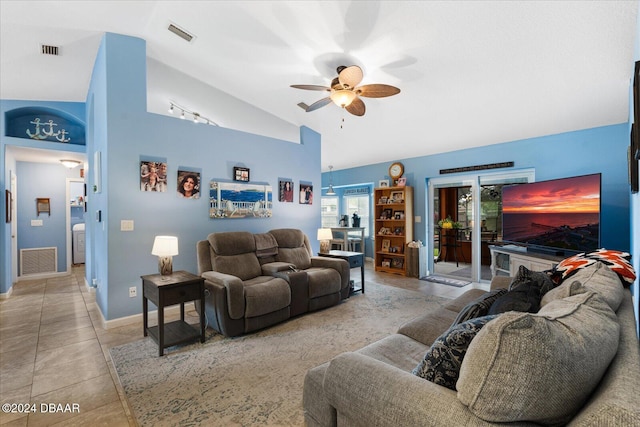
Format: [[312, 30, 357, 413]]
[[552, 249, 636, 286]]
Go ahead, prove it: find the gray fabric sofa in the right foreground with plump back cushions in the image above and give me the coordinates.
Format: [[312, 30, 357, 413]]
[[303, 262, 640, 427]]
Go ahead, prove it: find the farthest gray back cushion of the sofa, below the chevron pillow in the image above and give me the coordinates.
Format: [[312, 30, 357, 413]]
[[540, 261, 624, 311]]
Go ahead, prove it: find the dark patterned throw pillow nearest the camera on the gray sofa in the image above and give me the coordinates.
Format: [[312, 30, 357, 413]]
[[412, 316, 497, 390]]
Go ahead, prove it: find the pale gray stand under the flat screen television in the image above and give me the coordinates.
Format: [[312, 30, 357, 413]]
[[489, 245, 565, 277]]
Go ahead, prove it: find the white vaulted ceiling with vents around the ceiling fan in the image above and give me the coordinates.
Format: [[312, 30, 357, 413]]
[[0, 0, 639, 171]]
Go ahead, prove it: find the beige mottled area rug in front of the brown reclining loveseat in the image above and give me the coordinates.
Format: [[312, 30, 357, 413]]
[[109, 282, 447, 426]]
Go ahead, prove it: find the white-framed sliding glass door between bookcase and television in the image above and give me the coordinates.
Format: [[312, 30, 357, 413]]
[[426, 169, 535, 282]]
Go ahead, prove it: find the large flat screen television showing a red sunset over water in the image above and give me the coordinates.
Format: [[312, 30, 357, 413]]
[[502, 173, 601, 256]]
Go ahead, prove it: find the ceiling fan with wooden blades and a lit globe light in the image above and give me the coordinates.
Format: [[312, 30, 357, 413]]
[[291, 65, 400, 116]]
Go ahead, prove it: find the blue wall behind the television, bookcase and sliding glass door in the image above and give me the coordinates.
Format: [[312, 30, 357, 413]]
[[322, 123, 630, 251]]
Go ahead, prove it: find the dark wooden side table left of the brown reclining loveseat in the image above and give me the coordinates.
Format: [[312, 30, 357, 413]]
[[141, 271, 205, 356]]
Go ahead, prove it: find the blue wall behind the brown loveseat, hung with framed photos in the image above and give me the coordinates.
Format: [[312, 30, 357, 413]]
[[87, 34, 320, 320]]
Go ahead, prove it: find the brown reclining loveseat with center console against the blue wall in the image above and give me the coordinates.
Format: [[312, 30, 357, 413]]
[[196, 229, 350, 337]]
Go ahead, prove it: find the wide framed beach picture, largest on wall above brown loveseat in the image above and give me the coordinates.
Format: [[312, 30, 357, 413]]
[[209, 179, 273, 219]]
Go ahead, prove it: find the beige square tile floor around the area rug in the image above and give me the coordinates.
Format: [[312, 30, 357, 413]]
[[0, 265, 487, 426]]
